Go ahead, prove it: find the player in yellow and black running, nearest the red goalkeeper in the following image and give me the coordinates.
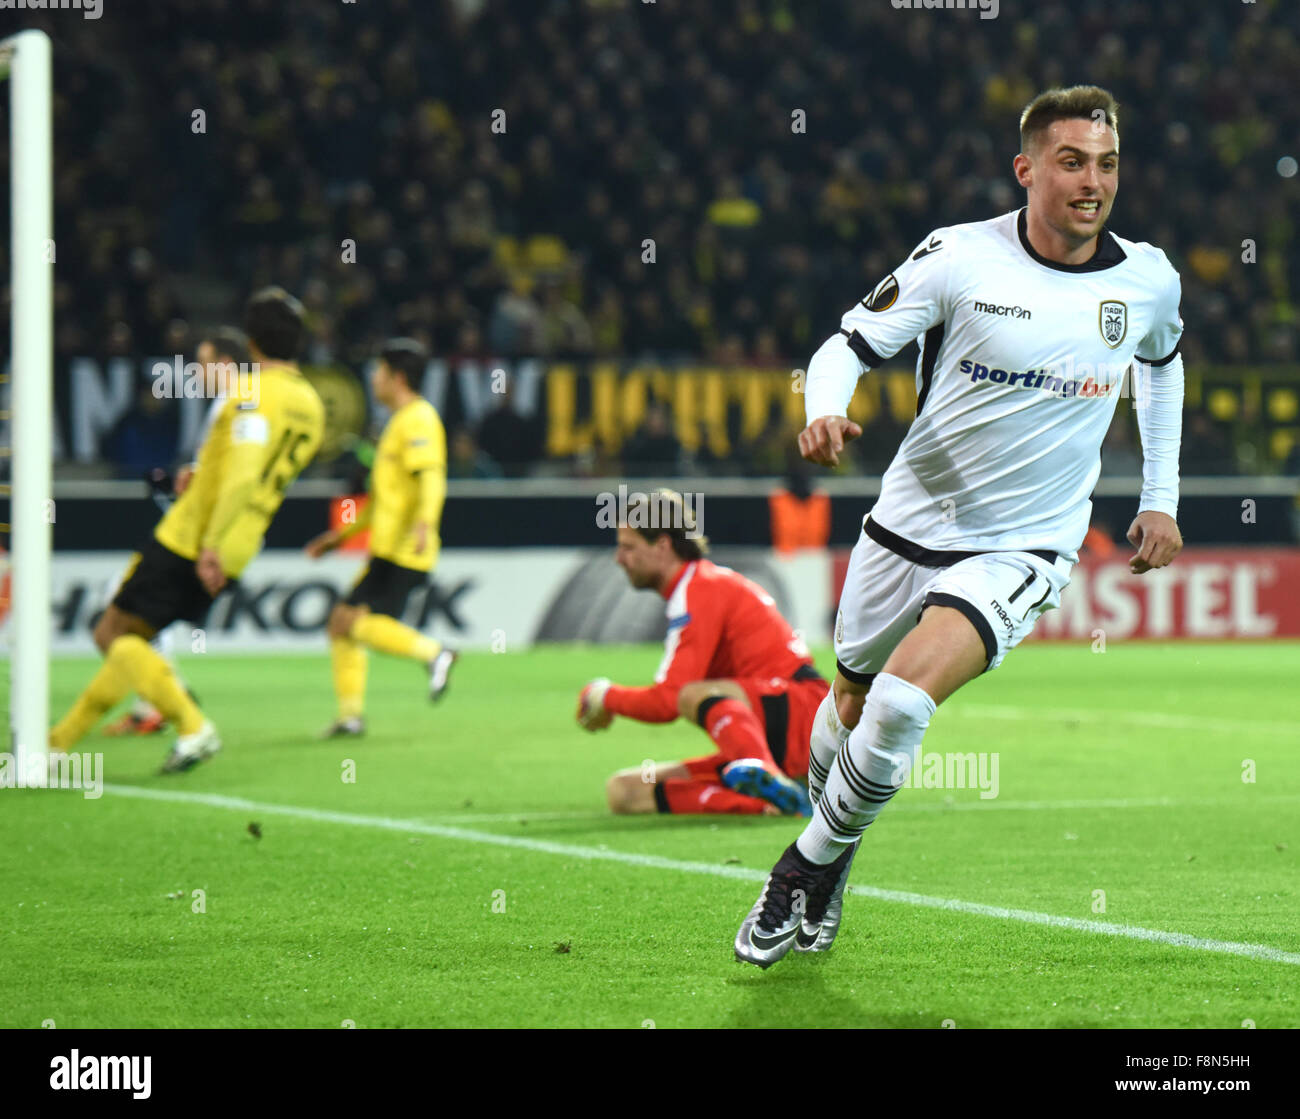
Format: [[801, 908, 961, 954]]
[[307, 338, 456, 738]]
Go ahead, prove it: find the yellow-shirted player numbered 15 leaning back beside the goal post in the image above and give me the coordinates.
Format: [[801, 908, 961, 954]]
[[49, 287, 325, 773]]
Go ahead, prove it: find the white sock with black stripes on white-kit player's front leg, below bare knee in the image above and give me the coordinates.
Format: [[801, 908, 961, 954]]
[[796, 672, 935, 866]]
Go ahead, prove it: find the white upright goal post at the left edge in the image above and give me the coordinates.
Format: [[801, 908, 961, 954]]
[[0, 31, 55, 784]]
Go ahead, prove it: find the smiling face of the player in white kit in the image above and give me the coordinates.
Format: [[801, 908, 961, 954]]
[[1028, 120, 1119, 244]]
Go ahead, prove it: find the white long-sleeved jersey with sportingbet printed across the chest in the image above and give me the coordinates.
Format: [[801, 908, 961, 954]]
[[805, 209, 1183, 561]]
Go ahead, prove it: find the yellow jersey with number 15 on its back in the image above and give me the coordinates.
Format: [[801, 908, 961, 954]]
[[153, 363, 325, 578]]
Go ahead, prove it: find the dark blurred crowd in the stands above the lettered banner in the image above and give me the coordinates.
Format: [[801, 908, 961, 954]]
[[3, 0, 1300, 473]]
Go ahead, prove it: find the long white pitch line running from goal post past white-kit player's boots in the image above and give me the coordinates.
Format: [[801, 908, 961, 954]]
[[104, 785, 1300, 966]]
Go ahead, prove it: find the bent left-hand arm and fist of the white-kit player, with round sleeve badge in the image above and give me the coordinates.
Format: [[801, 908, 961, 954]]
[[800, 229, 952, 467]]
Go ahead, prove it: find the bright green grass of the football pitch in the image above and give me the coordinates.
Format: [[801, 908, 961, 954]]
[[0, 643, 1300, 1028]]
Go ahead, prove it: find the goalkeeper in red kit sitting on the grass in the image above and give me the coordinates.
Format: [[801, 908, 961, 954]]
[[577, 490, 829, 816]]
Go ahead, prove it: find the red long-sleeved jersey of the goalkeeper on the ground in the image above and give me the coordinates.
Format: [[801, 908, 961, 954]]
[[605, 560, 813, 723]]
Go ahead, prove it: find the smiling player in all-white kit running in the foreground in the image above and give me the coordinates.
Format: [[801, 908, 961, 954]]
[[735, 86, 1183, 967]]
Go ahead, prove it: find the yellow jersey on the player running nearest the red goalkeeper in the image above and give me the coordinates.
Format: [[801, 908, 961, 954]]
[[371, 396, 447, 571]]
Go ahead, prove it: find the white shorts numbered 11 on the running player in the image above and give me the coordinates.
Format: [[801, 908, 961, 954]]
[[835, 519, 1071, 684]]
